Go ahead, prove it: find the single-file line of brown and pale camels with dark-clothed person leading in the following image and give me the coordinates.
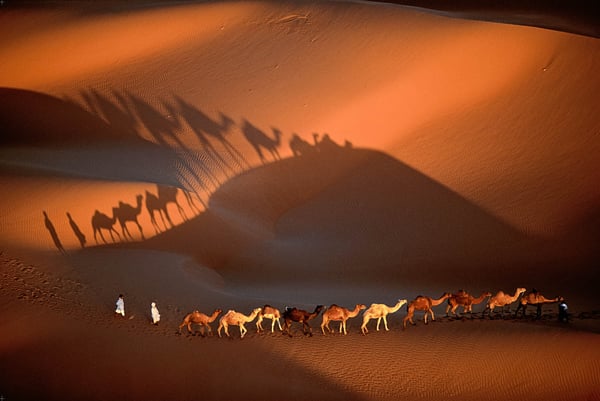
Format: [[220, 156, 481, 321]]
[[173, 288, 568, 338]]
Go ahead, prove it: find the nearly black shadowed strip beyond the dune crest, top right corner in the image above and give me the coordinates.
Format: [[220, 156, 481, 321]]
[[376, 0, 600, 38]]
